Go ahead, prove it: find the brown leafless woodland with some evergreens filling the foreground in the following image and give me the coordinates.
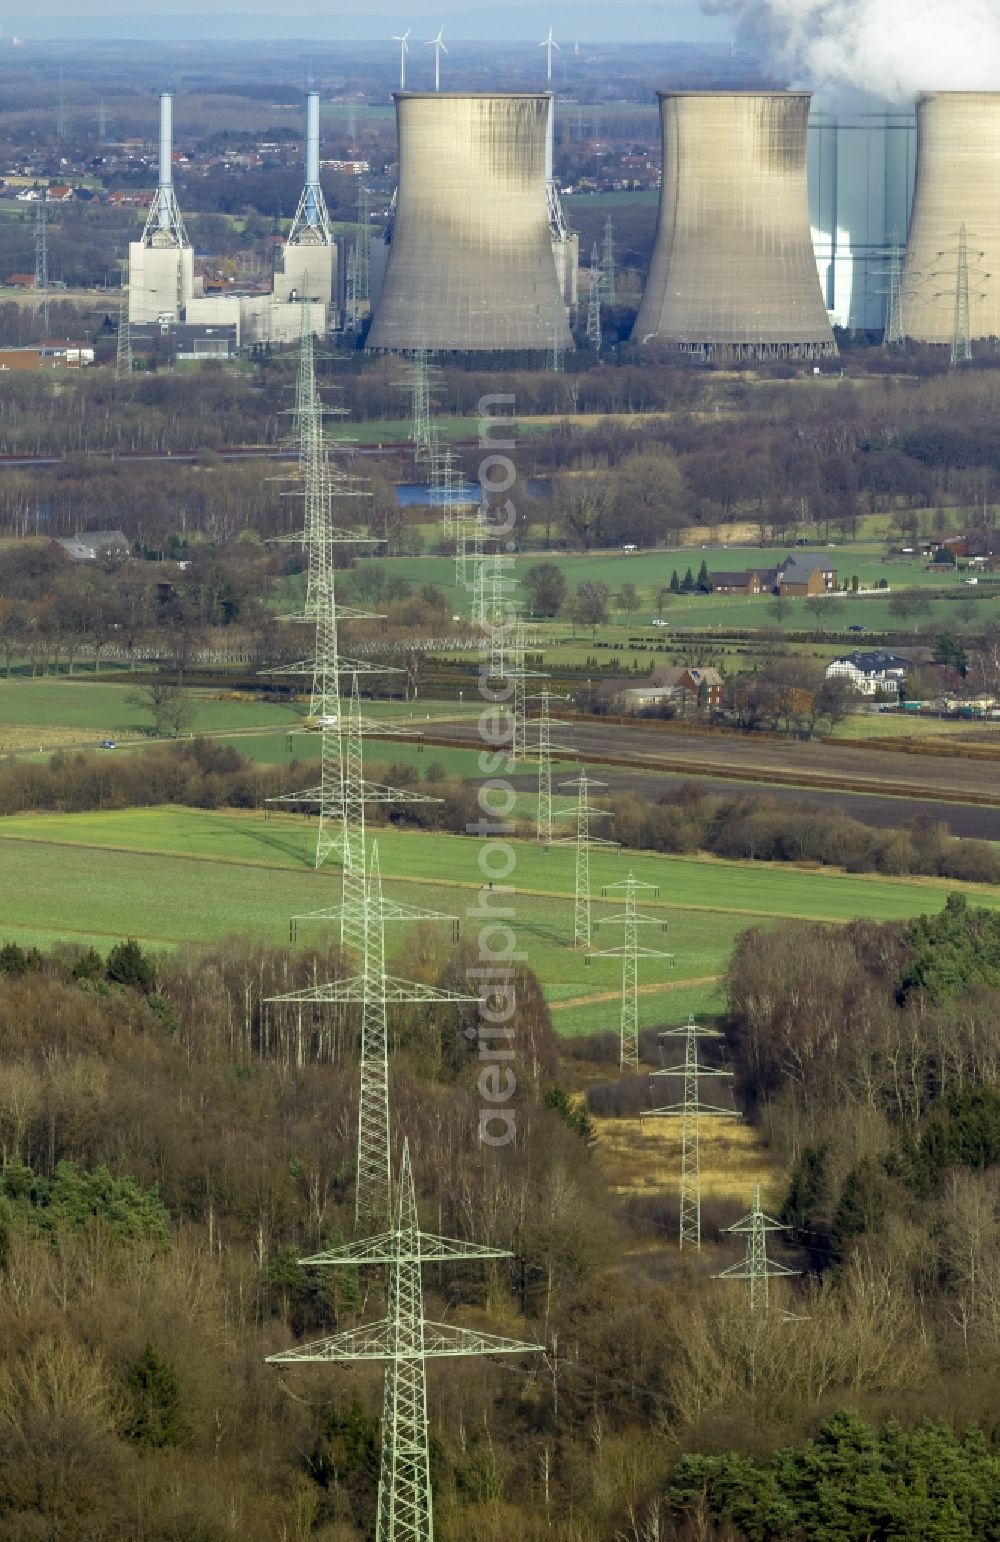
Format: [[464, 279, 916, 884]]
[[0, 902, 1000, 1542]]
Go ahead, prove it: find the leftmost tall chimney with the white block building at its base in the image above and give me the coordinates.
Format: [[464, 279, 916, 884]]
[[128, 91, 196, 325]]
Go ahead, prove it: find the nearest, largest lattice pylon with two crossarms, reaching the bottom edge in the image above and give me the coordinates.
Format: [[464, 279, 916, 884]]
[[268, 1141, 544, 1542]]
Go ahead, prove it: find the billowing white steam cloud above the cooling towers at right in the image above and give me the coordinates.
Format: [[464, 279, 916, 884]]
[[703, 0, 1000, 99]]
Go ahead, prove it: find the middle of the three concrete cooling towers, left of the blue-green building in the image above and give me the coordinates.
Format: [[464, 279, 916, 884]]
[[633, 91, 837, 359]]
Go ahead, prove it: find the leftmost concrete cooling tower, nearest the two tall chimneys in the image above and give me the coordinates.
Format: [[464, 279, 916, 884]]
[[367, 93, 573, 352]]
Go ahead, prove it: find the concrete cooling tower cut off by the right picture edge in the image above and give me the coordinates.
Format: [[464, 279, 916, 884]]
[[900, 91, 1000, 344]]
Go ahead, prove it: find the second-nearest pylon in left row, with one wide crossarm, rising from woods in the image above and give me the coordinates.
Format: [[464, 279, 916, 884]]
[[267, 842, 482, 1226]]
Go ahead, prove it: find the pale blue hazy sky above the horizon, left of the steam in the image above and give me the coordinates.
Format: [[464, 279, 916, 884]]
[[19, 0, 730, 43]]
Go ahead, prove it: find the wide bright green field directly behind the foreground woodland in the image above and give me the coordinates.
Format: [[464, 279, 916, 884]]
[[0, 808, 1000, 1033]]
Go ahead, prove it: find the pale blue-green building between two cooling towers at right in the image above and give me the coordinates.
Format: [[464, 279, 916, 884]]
[[809, 108, 917, 332]]
